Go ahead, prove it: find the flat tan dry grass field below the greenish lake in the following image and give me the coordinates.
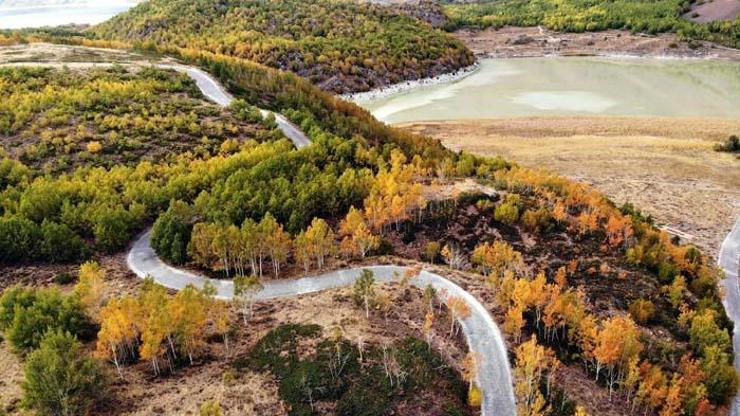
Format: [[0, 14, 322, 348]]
[[403, 117, 740, 256]]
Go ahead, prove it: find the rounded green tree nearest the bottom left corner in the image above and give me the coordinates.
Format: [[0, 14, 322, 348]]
[[22, 331, 106, 416]]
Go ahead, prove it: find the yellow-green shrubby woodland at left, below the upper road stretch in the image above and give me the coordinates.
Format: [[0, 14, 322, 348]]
[[0, 65, 279, 173]]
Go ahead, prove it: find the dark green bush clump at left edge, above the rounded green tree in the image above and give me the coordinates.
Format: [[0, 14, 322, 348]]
[[0, 287, 94, 352]]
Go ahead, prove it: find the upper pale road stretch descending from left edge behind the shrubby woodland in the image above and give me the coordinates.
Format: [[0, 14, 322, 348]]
[[0, 62, 311, 149]]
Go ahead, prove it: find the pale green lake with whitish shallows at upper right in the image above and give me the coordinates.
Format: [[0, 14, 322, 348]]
[[356, 57, 740, 123]]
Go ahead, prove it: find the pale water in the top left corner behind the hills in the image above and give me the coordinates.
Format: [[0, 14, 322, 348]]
[[0, 1, 135, 29]]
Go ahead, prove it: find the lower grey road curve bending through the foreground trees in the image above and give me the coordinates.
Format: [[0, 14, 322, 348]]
[[126, 230, 516, 416]]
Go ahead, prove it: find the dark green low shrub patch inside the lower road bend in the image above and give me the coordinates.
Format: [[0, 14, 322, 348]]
[[234, 324, 470, 416]]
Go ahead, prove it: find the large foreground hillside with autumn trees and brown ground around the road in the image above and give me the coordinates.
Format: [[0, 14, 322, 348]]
[[0, 33, 737, 416]]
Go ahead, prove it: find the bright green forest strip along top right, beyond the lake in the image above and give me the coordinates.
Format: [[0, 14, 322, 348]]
[[444, 0, 740, 48]]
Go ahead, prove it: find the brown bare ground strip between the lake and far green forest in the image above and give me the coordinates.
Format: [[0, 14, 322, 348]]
[[453, 25, 740, 60]]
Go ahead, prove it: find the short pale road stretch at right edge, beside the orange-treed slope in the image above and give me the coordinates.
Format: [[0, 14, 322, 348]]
[[718, 218, 740, 416]]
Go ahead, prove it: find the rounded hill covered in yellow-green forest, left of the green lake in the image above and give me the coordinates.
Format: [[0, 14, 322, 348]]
[[93, 0, 473, 92]]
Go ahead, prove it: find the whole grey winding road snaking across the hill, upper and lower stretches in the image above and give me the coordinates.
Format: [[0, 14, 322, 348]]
[[0, 50, 516, 416]]
